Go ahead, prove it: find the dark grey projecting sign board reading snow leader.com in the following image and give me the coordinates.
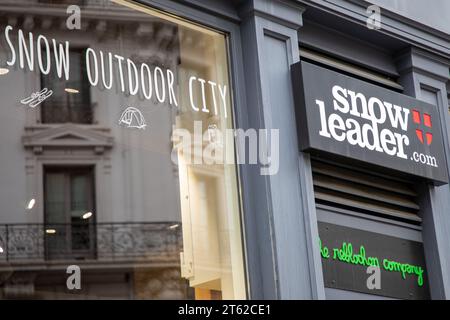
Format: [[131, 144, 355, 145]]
[[292, 61, 448, 185]]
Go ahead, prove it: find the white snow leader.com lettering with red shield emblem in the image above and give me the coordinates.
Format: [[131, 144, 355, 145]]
[[315, 85, 438, 167]]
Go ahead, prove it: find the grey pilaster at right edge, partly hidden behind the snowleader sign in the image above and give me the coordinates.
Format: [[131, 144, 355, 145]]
[[398, 48, 450, 299]]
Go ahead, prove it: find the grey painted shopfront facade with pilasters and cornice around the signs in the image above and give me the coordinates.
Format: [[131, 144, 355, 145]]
[[140, 0, 450, 299]]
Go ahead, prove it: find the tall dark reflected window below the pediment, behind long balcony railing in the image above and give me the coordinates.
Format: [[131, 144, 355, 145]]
[[44, 167, 96, 259]]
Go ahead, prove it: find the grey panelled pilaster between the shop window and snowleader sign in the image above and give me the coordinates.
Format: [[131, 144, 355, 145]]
[[239, 0, 325, 299]]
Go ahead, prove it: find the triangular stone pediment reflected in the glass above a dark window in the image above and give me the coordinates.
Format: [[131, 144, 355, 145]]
[[22, 123, 113, 154]]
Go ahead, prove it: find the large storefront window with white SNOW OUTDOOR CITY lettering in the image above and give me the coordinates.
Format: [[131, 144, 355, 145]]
[[0, 0, 246, 299]]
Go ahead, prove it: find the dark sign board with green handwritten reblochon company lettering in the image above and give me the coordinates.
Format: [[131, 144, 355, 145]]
[[319, 222, 430, 299]]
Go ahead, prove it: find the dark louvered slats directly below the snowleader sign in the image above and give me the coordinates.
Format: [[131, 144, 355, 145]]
[[312, 158, 422, 223]]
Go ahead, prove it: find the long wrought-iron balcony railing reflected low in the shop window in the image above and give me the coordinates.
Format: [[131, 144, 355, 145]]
[[0, 222, 182, 264]]
